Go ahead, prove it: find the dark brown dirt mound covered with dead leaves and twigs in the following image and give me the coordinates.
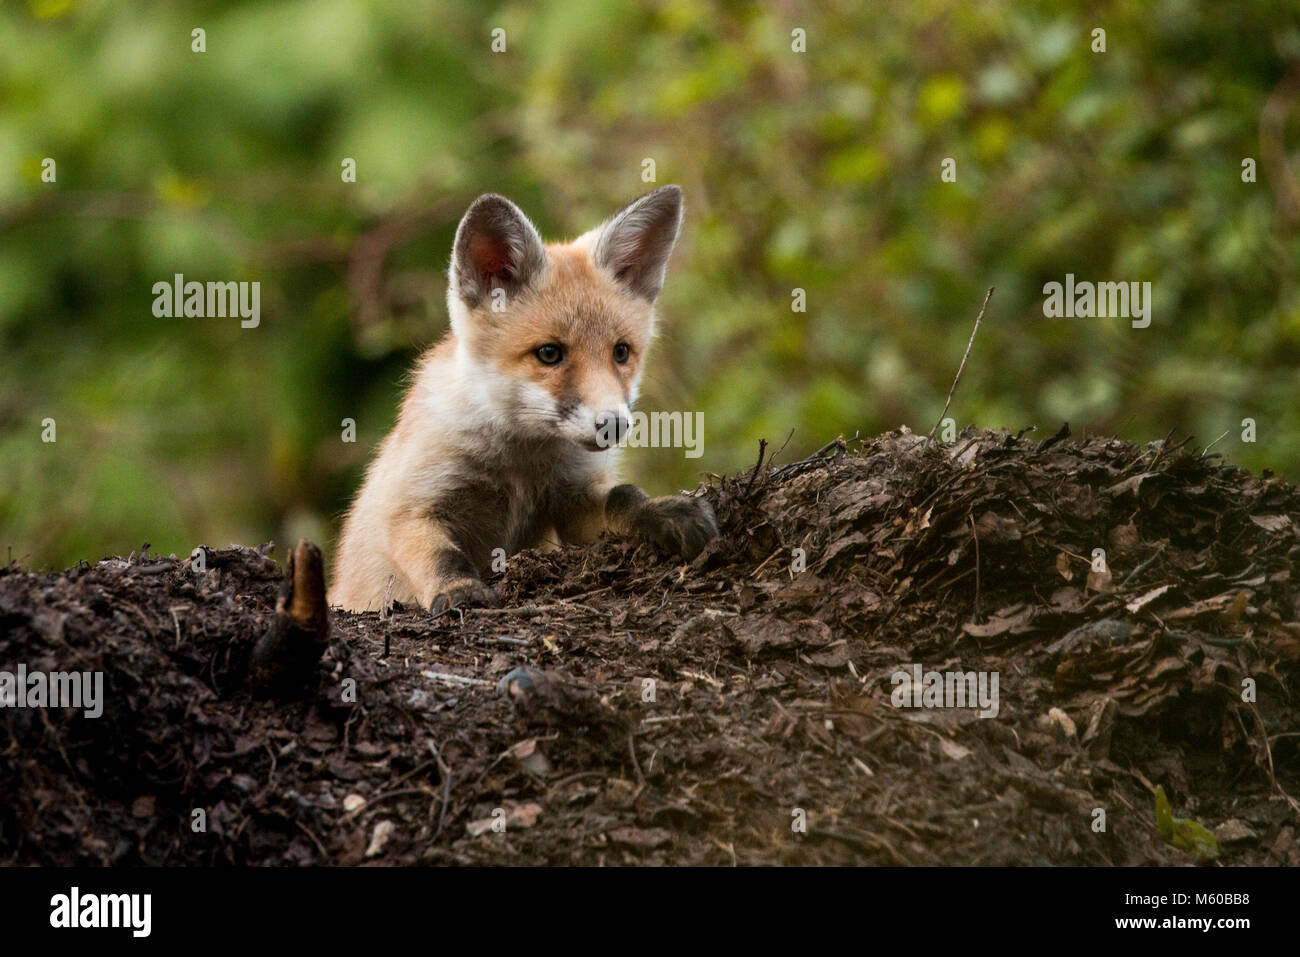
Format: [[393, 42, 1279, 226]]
[[0, 430, 1300, 865]]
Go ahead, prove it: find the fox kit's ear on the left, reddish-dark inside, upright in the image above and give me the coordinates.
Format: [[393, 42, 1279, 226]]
[[451, 192, 546, 308]]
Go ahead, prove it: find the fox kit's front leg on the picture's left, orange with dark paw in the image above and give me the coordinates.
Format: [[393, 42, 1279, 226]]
[[389, 512, 501, 615]]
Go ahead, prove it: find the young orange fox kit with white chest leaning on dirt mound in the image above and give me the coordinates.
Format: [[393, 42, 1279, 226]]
[[329, 186, 718, 614]]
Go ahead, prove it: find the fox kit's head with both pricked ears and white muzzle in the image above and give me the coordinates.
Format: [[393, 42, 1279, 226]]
[[447, 186, 681, 451]]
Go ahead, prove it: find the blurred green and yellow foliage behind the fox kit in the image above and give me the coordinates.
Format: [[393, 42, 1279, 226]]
[[0, 0, 1300, 566]]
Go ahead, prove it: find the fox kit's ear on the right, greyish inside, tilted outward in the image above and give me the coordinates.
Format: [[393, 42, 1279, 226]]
[[595, 186, 681, 302]]
